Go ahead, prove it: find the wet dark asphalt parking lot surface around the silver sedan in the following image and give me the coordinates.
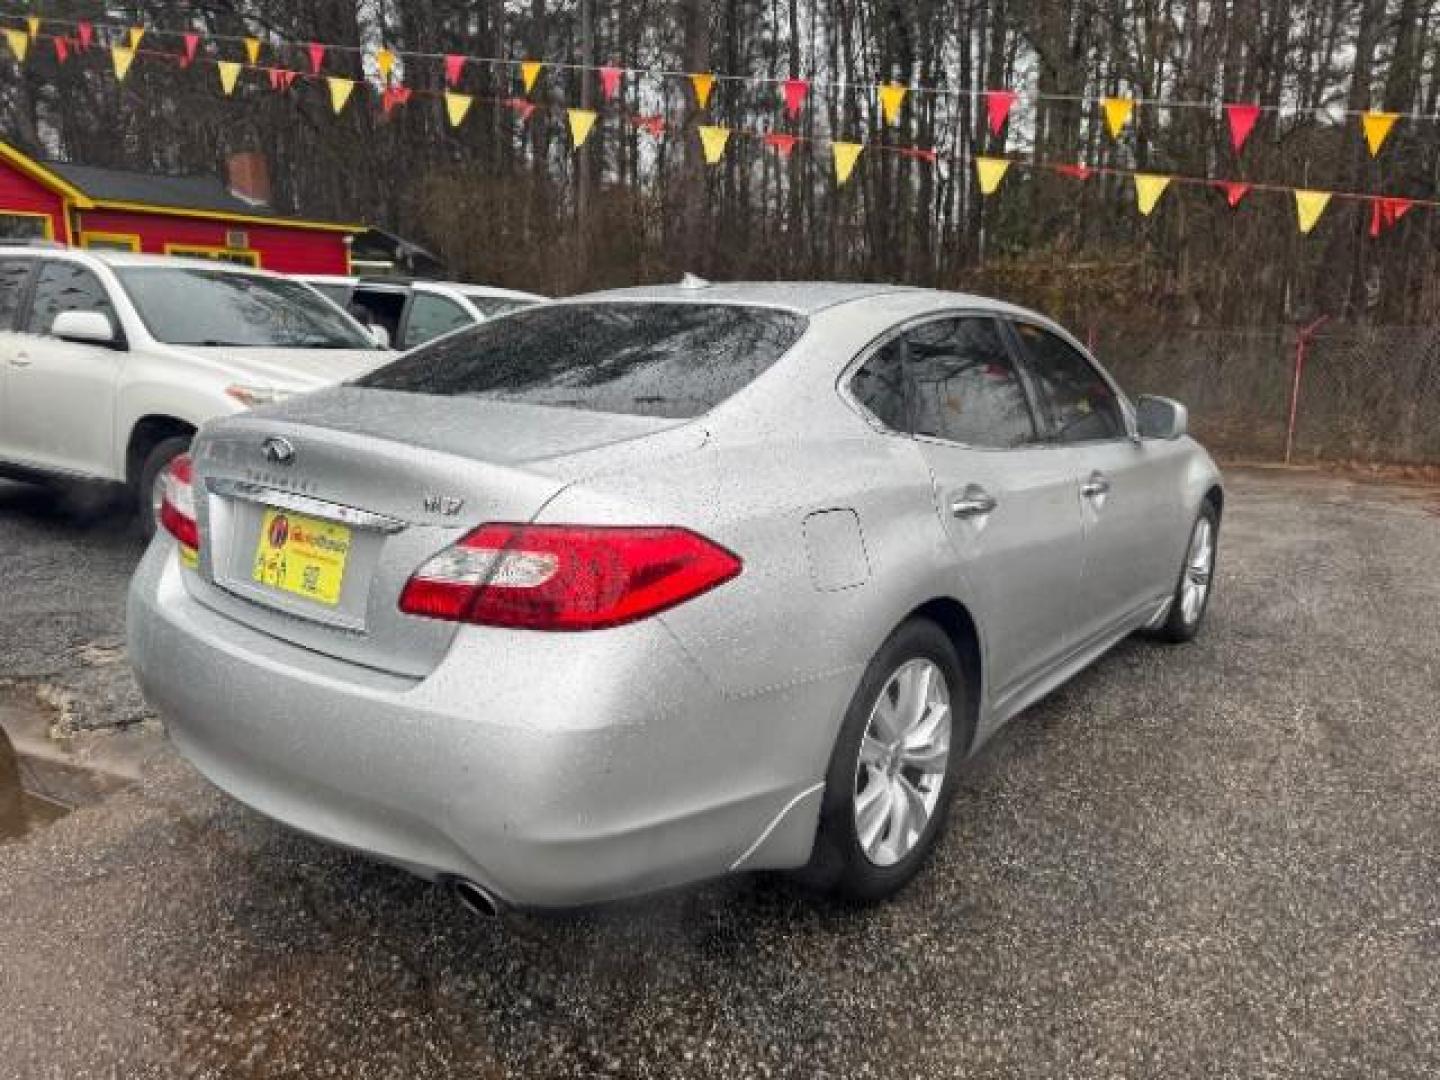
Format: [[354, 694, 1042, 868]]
[[0, 471, 1440, 1080]]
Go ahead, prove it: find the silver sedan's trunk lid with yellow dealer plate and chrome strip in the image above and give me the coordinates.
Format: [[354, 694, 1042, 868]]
[[186, 387, 691, 677]]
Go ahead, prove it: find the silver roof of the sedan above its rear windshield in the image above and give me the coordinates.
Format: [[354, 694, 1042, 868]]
[[560, 279, 1028, 315]]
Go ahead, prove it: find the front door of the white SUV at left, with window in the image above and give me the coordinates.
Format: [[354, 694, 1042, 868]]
[[0, 259, 125, 478]]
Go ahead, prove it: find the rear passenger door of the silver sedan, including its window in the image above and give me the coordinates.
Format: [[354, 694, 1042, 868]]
[[852, 315, 1083, 707]]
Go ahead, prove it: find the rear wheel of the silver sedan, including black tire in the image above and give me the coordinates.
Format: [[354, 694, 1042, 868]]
[[802, 619, 973, 903]]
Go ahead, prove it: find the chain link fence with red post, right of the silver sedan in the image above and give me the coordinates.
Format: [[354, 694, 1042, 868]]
[[1090, 323, 1440, 465]]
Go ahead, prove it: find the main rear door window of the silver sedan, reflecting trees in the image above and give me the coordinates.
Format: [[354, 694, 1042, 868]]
[[904, 317, 1035, 449]]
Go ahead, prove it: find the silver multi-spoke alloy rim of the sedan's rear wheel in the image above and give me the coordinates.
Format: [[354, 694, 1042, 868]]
[[852, 658, 952, 867]]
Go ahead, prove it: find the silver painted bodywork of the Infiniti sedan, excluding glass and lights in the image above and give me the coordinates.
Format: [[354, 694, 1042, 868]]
[[130, 284, 1220, 906]]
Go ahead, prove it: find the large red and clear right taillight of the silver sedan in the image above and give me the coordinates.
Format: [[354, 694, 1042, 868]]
[[400, 524, 740, 631]]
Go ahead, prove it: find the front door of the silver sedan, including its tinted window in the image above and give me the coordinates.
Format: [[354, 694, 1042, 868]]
[[1011, 320, 1182, 647]]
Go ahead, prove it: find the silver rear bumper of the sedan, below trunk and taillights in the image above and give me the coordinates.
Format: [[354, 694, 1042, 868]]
[[128, 537, 850, 907]]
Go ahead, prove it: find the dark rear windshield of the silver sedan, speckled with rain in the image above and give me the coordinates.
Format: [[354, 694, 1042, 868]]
[[357, 302, 806, 419]]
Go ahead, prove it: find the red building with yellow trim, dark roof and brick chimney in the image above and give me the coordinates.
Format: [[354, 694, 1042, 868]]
[[0, 143, 364, 274]]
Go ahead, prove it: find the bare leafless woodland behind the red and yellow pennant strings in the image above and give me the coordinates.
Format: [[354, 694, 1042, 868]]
[[0, 0, 1440, 333]]
